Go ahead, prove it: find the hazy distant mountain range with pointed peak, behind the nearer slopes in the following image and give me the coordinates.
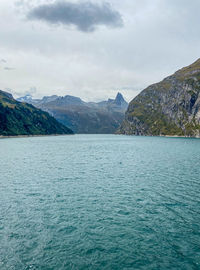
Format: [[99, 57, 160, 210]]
[[18, 93, 128, 134]]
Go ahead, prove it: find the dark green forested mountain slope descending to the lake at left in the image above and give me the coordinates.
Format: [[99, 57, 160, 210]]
[[0, 90, 73, 136]]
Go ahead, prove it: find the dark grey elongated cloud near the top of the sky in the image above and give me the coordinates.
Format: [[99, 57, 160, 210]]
[[27, 1, 123, 32]]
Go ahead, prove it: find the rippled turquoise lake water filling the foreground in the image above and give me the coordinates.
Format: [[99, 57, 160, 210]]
[[0, 135, 200, 270]]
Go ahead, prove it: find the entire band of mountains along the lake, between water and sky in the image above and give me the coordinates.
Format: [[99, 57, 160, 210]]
[[0, 59, 200, 137]]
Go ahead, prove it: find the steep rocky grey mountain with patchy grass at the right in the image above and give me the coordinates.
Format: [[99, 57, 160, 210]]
[[118, 59, 200, 137]]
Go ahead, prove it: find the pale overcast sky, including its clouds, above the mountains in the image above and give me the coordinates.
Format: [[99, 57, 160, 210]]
[[0, 0, 200, 101]]
